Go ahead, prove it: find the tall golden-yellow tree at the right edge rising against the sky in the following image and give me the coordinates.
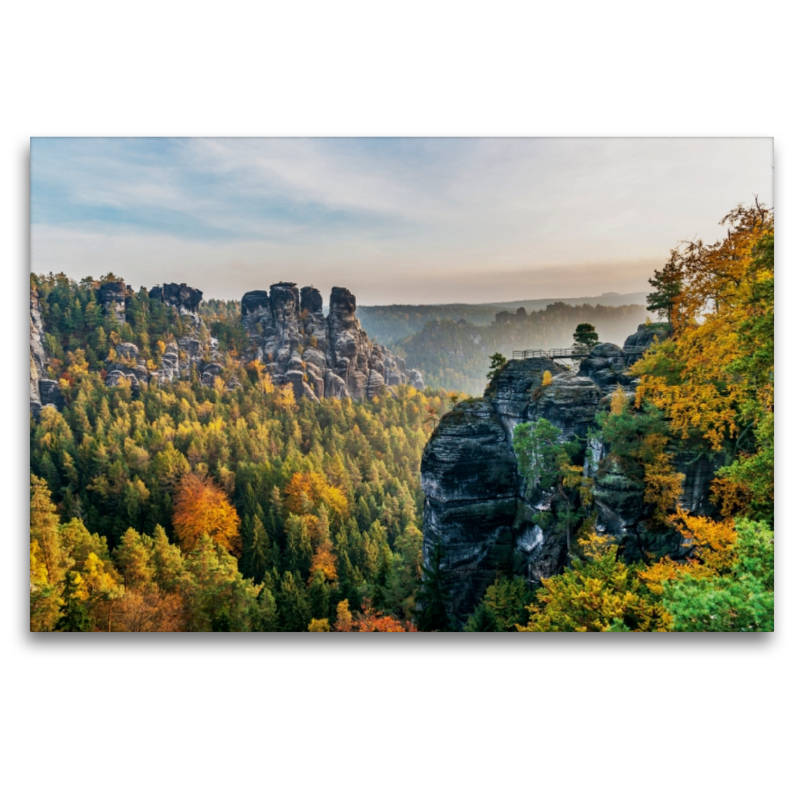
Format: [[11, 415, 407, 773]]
[[632, 204, 774, 450]]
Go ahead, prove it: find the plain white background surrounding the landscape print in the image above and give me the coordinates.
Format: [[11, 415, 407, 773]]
[[0, 0, 800, 798]]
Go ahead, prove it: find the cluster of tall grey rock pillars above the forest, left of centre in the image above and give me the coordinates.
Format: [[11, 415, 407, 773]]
[[242, 283, 424, 400]]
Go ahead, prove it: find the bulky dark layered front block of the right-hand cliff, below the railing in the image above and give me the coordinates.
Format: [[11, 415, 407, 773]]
[[421, 357, 601, 621]]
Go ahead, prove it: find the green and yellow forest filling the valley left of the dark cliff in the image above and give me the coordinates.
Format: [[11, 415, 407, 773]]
[[31, 275, 462, 631]]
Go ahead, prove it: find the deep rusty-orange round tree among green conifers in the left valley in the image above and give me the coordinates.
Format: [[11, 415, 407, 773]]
[[172, 473, 241, 555]]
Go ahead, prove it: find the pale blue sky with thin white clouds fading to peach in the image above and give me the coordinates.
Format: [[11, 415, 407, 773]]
[[31, 138, 773, 305]]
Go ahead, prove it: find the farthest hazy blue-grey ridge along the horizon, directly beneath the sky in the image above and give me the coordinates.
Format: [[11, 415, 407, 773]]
[[358, 292, 646, 346]]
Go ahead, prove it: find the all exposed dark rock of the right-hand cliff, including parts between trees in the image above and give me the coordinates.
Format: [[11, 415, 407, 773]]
[[421, 332, 718, 622]]
